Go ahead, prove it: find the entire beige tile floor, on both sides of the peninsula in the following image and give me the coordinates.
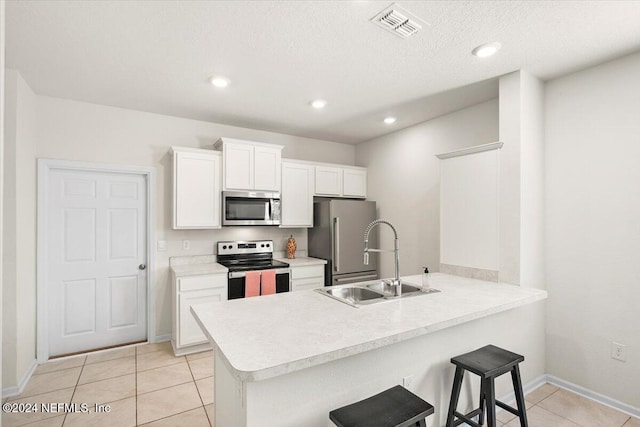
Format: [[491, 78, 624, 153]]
[[2, 343, 640, 427]]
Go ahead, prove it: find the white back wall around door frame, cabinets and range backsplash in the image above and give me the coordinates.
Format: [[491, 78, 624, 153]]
[[36, 96, 355, 342]]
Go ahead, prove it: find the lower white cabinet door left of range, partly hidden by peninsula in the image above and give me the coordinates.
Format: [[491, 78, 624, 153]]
[[178, 288, 226, 347]]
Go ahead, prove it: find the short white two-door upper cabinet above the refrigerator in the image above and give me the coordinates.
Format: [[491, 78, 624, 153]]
[[315, 165, 367, 198]]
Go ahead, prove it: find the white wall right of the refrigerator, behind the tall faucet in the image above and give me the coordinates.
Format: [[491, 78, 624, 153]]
[[356, 99, 498, 277]]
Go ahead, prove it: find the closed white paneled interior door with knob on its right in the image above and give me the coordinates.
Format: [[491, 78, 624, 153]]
[[46, 169, 147, 356]]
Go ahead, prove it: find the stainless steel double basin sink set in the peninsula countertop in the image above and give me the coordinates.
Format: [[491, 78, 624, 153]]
[[316, 280, 440, 307]]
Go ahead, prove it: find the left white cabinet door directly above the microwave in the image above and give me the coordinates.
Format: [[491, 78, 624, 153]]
[[223, 143, 255, 190]]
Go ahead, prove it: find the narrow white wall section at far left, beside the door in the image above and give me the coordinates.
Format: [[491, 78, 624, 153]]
[[2, 71, 37, 386]]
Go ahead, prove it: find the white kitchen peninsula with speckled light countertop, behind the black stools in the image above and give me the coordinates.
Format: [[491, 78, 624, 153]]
[[191, 274, 547, 427]]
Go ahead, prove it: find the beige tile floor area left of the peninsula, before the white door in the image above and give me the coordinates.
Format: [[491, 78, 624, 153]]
[[2, 342, 214, 427]]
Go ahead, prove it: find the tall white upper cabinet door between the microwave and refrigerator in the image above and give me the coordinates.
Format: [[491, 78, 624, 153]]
[[280, 162, 314, 227]]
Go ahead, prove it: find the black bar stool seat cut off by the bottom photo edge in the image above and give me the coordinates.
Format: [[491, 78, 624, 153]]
[[329, 385, 433, 427]]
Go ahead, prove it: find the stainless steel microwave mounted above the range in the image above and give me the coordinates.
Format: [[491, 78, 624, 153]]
[[222, 191, 280, 225]]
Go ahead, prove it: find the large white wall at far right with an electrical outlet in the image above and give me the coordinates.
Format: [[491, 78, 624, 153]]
[[545, 50, 640, 408]]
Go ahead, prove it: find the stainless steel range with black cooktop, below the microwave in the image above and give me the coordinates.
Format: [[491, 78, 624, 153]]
[[218, 240, 291, 299]]
